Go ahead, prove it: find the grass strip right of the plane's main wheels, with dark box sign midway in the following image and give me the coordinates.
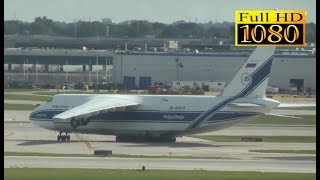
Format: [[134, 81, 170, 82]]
[[191, 135, 316, 143]]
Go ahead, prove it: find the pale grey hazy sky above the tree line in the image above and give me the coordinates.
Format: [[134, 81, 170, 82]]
[[4, 0, 316, 23]]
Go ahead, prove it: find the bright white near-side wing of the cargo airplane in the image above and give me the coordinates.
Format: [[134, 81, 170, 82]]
[[53, 97, 140, 121]]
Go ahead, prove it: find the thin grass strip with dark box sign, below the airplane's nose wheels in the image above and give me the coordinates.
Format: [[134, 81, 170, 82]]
[[4, 151, 237, 159]]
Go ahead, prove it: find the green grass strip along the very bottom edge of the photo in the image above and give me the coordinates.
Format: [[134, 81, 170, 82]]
[[4, 167, 316, 180]]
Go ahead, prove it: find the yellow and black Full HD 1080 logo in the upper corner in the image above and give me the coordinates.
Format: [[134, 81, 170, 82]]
[[235, 10, 306, 46]]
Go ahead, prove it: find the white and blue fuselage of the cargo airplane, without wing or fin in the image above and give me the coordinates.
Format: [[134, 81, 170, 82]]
[[30, 94, 279, 136]]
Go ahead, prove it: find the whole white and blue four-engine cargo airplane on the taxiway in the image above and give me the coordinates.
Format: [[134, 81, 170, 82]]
[[29, 47, 310, 142]]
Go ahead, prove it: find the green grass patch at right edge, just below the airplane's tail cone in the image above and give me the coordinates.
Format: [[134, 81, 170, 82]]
[[244, 115, 317, 125]]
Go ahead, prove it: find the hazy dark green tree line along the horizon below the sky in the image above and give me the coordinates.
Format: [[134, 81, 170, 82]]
[[4, 16, 316, 42]]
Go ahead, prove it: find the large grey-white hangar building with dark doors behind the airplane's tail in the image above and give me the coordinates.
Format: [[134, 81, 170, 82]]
[[113, 51, 316, 91]]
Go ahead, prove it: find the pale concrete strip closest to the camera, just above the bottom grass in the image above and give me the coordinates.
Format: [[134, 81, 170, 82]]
[[4, 156, 316, 173]]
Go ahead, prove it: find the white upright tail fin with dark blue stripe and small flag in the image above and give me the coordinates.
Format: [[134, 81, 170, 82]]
[[219, 46, 276, 97]]
